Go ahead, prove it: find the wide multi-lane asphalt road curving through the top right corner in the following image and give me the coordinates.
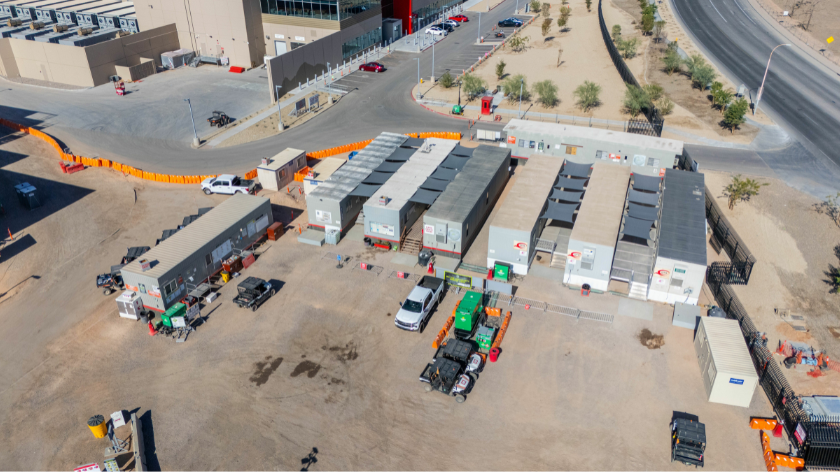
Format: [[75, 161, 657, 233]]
[[673, 0, 840, 189]]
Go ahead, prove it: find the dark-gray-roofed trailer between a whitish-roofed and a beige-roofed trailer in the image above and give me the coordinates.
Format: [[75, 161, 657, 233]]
[[423, 146, 510, 259]]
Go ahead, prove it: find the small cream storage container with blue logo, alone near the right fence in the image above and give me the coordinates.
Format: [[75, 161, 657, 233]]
[[694, 316, 758, 408]]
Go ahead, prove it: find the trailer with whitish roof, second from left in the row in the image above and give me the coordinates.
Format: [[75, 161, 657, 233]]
[[364, 138, 458, 244]]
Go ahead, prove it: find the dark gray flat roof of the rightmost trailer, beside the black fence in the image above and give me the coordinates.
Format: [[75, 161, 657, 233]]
[[659, 169, 706, 266]]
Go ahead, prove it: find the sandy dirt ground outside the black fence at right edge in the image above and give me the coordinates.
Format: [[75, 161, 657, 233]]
[[705, 172, 840, 395]]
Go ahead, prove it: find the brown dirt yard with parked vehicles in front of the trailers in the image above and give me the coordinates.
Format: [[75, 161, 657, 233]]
[[0, 131, 771, 470]]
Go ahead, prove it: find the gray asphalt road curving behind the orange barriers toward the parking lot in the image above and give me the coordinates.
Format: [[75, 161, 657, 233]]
[[0, 0, 516, 174]]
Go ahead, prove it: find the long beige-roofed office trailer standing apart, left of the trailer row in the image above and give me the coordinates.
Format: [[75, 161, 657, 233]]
[[121, 194, 274, 312]]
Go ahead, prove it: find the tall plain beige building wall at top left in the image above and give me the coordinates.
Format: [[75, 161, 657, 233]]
[[134, 0, 265, 68]]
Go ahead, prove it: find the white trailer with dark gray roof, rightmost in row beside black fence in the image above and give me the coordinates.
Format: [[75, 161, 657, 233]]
[[648, 169, 706, 305]]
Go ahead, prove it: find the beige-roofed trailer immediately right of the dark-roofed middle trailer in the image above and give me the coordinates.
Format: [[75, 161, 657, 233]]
[[487, 154, 563, 275]]
